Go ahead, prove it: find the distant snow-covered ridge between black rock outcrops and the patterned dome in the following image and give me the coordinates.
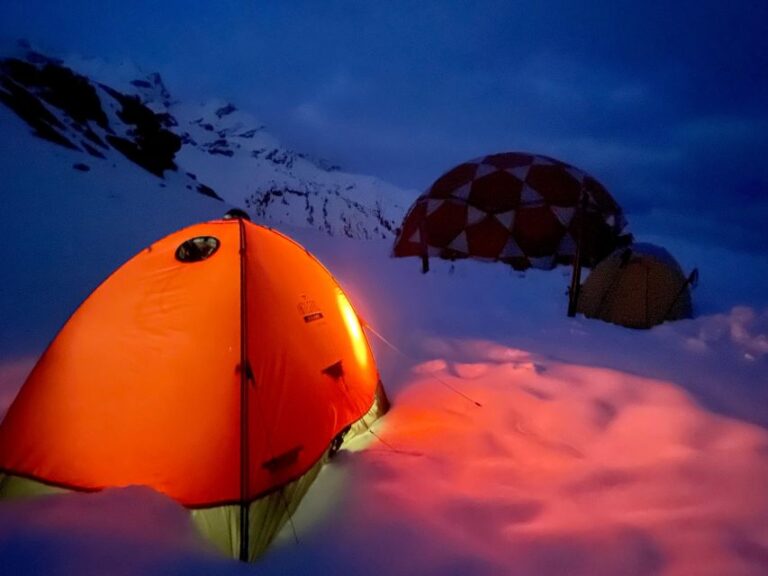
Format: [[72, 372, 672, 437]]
[[169, 102, 408, 238]]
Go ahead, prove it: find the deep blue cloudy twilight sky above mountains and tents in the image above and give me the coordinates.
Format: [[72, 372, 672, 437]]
[[0, 0, 768, 250]]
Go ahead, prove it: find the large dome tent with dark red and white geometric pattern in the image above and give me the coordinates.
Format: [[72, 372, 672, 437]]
[[394, 152, 626, 270]]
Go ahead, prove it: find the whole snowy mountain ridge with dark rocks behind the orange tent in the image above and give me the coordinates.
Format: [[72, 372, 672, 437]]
[[0, 44, 415, 238]]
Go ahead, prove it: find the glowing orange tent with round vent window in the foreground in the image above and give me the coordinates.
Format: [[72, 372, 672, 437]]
[[0, 218, 387, 560]]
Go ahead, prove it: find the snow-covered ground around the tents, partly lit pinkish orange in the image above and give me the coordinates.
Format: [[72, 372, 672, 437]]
[[0, 77, 768, 576]]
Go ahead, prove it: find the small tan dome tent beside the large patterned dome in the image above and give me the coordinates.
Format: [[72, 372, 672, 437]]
[[577, 243, 698, 328]]
